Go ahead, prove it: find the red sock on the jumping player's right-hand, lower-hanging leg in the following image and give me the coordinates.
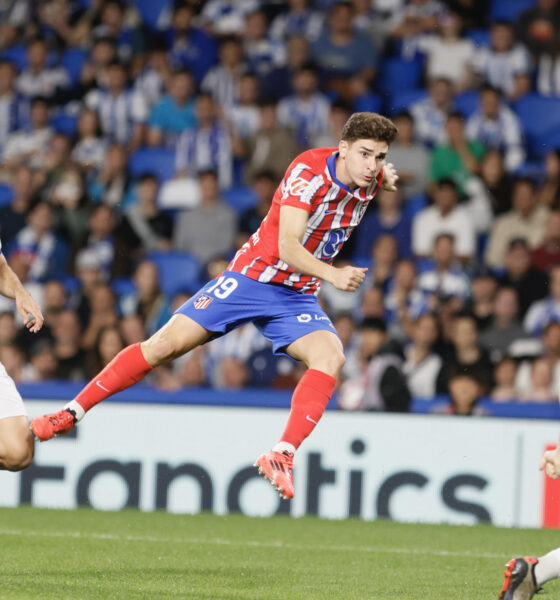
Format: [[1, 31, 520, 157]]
[[280, 369, 336, 448]]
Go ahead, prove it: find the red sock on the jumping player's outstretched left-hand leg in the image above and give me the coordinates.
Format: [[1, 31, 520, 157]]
[[74, 343, 153, 412]]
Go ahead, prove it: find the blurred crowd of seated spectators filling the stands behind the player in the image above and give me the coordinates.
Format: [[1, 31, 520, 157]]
[[0, 0, 560, 414]]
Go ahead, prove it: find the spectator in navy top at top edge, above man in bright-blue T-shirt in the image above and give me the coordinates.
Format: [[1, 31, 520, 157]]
[[167, 2, 216, 84]]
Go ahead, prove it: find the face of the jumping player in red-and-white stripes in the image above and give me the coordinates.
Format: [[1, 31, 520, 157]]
[[337, 140, 389, 189]]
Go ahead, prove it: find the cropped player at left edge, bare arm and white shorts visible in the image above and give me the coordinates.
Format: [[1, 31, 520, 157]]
[[0, 238, 44, 471]]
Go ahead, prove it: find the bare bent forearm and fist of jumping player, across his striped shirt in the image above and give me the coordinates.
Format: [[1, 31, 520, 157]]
[[278, 204, 367, 292]]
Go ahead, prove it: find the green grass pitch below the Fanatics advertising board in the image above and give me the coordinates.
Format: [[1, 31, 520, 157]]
[[0, 508, 560, 600]]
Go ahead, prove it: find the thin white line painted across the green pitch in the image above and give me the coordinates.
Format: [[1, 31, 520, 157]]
[[0, 529, 509, 559]]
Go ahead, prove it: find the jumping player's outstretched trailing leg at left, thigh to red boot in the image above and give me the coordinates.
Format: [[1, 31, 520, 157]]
[[31, 314, 212, 441]]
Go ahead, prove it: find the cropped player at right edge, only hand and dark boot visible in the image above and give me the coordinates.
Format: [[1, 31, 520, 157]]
[[498, 439, 560, 600]]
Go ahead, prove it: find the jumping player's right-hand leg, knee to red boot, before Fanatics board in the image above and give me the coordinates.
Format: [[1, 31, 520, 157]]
[[255, 330, 345, 498]]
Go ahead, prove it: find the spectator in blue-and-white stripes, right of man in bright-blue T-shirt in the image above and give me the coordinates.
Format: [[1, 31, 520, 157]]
[[175, 94, 233, 189]]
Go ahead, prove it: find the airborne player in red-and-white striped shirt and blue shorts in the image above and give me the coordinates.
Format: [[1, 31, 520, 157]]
[[31, 113, 398, 498]]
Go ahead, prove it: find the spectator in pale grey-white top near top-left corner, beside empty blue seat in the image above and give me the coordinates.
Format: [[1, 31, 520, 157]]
[[16, 38, 70, 102]]
